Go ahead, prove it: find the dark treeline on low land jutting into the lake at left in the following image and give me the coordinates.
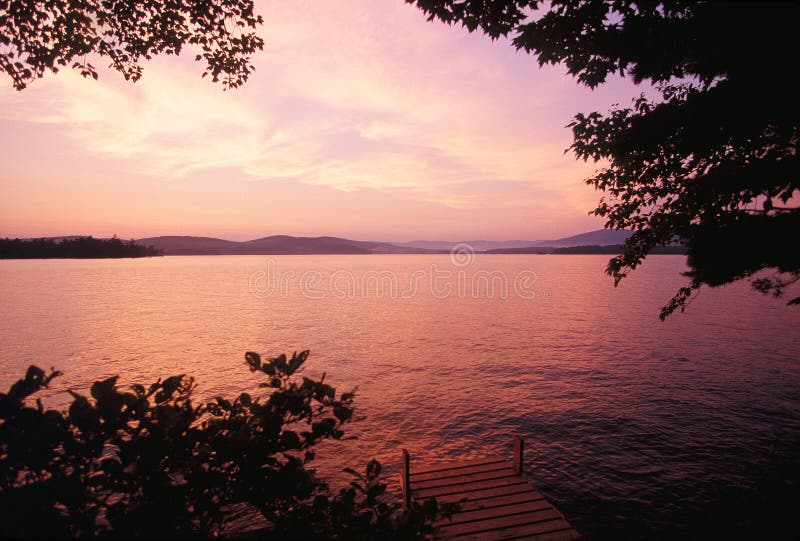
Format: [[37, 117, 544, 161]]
[[0, 236, 163, 259]]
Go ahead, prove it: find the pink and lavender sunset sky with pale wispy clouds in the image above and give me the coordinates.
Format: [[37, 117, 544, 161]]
[[0, 0, 642, 241]]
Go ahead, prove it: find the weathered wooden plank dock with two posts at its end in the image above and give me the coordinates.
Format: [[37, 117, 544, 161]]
[[400, 437, 580, 541]]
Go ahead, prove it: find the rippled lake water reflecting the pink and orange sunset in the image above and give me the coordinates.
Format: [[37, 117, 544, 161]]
[[0, 254, 800, 537]]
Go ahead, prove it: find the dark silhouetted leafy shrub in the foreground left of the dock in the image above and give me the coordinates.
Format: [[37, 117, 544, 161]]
[[0, 351, 444, 539]]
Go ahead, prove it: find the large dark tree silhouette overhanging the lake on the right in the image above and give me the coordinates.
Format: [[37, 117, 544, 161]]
[[407, 0, 800, 319]]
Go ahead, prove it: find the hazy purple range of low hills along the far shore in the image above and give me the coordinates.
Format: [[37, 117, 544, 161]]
[[136, 229, 632, 255]]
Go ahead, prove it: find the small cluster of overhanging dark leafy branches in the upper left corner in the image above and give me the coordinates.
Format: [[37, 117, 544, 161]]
[[0, 0, 264, 90]]
